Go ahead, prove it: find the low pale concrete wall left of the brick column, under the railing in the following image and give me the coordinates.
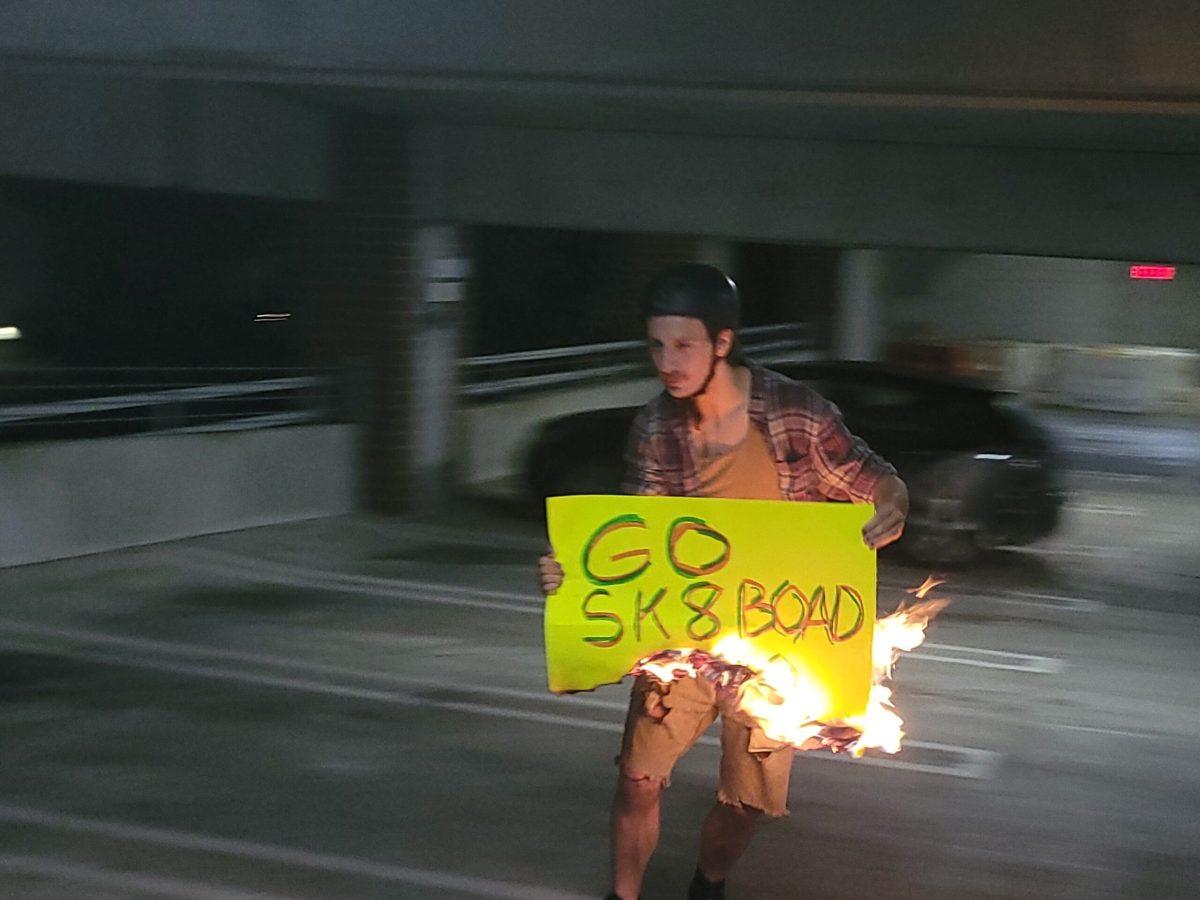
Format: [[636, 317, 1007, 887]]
[[0, 425, 358, 565]]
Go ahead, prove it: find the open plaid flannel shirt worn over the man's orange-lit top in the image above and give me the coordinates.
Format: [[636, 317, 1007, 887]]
[[623, 365, 896, 502]]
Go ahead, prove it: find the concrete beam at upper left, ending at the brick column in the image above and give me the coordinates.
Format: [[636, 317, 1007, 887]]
[[0, 73, 331, 199]]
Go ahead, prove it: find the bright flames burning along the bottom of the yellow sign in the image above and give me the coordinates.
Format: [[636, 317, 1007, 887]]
[[631, 578, 949, 756]]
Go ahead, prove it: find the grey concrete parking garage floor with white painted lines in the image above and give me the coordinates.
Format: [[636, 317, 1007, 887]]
[[0, 476, 1200, 900]]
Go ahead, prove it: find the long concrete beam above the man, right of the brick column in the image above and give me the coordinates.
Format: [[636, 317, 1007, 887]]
[[428, 126, 1200, 262]]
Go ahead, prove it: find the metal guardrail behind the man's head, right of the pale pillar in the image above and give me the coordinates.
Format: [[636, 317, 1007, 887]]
[[458, 323, 816, 400]]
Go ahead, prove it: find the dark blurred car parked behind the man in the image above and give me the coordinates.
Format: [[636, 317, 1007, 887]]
[[526, 362, 1063, 565]]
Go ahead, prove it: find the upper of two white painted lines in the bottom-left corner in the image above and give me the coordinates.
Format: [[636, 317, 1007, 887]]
[[0, 804, 590, 900]]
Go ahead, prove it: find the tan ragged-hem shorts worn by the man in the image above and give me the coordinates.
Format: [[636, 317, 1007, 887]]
[[617, 677, 796, 816]]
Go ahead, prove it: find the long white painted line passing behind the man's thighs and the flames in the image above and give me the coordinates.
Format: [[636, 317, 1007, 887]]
[[0, 628, 994, 778]]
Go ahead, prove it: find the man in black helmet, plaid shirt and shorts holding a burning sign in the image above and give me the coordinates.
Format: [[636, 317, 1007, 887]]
[[539, 263, 908, 900]]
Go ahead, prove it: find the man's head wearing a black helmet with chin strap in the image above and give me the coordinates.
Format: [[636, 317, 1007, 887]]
[[643, 263, 742, 400]]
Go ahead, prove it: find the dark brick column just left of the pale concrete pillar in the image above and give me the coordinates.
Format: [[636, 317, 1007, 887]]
[[288, 116, 416, 514]]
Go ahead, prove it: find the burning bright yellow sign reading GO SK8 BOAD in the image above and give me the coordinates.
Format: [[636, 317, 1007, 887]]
[[545, 496, 875, 720]]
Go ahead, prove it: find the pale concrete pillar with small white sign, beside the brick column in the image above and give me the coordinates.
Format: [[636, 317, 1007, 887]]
[[410, 224, 470, 505]]
